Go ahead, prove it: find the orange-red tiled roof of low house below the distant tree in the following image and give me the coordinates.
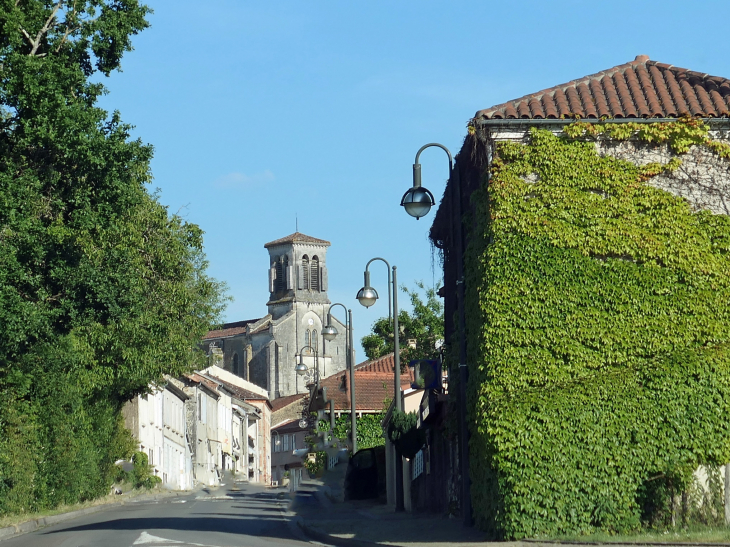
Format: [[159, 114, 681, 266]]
[[320, 353, 413, 412]]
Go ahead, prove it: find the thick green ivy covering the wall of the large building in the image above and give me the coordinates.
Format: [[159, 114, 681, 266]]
[[466, 120, 730, 538]]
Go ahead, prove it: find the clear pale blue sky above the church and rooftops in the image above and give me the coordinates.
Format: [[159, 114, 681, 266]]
[[95, 0, 730, 361]]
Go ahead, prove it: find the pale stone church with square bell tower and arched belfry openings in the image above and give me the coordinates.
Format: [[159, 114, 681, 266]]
[[203, 232, 346, 400]]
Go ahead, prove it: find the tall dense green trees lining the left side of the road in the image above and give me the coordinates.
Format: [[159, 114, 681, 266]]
[[0, 0, 225, 514]]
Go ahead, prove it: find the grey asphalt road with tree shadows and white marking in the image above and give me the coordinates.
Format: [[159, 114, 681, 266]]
[[0, 484, 311, 547]]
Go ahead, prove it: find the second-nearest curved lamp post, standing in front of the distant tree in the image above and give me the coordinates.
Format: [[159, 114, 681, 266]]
[[356, 257, 404, 511]]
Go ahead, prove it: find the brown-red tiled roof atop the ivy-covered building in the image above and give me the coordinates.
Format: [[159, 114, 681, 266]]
[[474, 55, 730, 120]]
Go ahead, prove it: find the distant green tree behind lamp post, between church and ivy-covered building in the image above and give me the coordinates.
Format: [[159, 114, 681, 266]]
[[362, 281, 444, 365]]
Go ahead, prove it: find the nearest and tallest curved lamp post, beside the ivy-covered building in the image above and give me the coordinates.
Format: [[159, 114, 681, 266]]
[[401, 142, 472, 526]]
